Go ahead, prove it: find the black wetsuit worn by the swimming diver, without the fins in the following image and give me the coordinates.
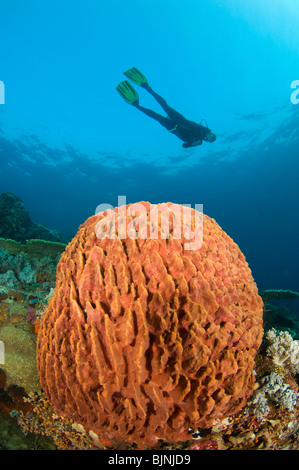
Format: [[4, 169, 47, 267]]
[[135, 85, 210, 147]]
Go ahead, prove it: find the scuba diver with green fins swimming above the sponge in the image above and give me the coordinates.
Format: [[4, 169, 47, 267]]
[[116, 67, 216, 148]]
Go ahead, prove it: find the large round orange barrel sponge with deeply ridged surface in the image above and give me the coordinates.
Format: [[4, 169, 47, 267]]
[[37, 202, 263, 446]]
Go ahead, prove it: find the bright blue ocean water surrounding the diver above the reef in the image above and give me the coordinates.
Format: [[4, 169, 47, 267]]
[[0, 0, 299, 291]]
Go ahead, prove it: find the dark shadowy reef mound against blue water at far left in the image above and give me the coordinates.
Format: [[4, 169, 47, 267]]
[[0, 192, 64, 242]]
